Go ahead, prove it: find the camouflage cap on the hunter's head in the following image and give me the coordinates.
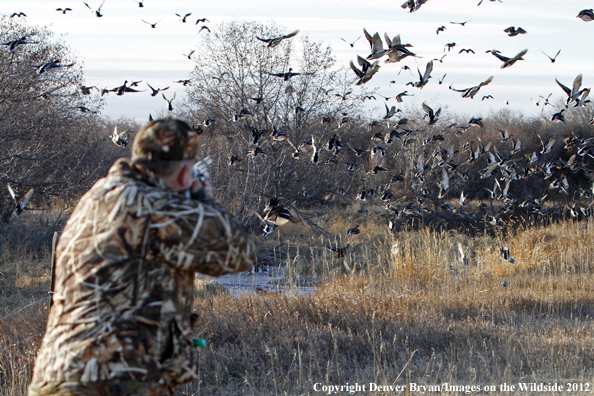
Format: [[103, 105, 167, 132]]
[[132, 117, 198, 161]]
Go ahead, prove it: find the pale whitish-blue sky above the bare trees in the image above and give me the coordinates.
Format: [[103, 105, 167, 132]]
[[0, 0, 594, 121]]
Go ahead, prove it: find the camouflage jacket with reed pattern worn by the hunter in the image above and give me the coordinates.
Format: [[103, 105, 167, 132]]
[[30, 159, 255, 395]]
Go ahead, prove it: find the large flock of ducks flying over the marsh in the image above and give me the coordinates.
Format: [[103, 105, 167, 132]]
[[2, 0, 594, 261]]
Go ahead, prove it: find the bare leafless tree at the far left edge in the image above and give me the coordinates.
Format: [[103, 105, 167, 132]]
[[0, 18, 103, 218]]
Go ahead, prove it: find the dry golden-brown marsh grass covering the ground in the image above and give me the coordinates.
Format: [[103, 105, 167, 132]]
[[0, 215, 594, 396]]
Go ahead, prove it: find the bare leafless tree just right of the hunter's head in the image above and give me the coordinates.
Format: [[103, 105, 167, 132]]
[[179, 21, 364, 221]]
